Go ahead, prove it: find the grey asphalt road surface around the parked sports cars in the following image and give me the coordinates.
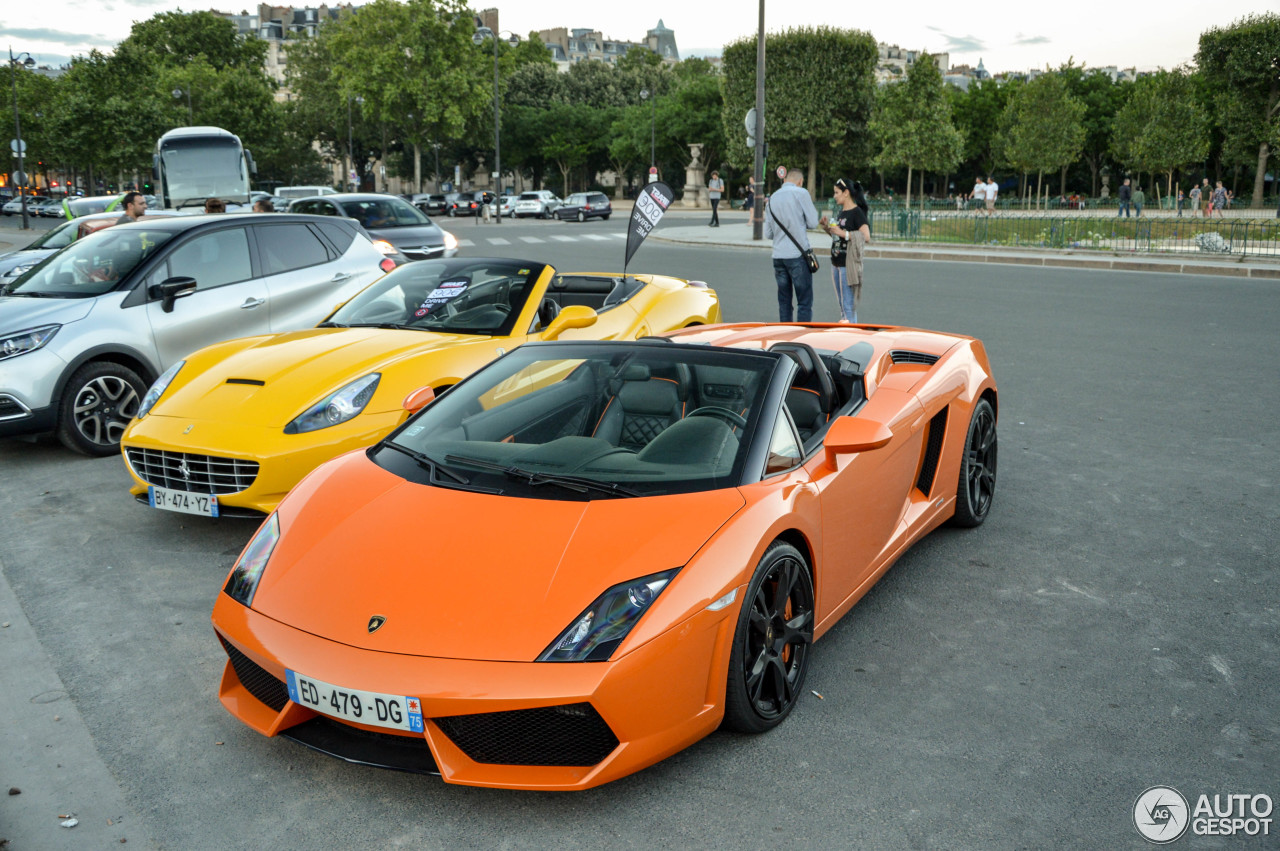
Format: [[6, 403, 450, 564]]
[[0, 208, 1280, 851]]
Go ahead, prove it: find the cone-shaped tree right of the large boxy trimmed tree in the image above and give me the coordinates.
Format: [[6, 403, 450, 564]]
[[870, 54, 964, 207]]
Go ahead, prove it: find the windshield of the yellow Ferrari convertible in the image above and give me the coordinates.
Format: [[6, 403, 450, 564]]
[[326, 258, 548, 335]]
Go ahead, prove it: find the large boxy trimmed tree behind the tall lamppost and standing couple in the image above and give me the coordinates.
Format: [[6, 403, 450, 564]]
[[721, 27, 879, 195]]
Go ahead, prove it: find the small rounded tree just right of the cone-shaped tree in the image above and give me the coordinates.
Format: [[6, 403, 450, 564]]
[[1000, 72, 1084, 207]]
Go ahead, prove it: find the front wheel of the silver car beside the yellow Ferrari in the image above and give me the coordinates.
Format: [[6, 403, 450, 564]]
[[58, 361, 147, 457]]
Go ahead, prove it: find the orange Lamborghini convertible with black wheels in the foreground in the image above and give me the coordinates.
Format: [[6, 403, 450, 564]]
[[212, 324, 997, 790]]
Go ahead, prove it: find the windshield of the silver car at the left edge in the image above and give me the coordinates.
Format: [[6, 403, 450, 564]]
[[9, 223, 173, 298]]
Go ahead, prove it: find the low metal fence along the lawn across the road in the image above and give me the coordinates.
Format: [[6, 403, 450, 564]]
[[849, 209, 1280, 257]]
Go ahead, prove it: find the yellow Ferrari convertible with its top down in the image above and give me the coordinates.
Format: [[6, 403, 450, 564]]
[[122, 257, 721, 517]]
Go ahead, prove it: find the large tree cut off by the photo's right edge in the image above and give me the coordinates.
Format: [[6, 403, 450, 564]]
[[1196, 12, 1280, 207]]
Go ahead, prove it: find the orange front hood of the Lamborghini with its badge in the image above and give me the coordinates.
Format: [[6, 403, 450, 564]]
[[253, 452, 744, 664]]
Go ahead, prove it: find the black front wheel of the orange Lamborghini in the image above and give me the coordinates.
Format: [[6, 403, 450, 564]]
[[723, 541, 814, 733]]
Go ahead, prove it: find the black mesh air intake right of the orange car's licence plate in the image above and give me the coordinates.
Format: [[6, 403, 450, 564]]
[[433, 704, 618, 765]]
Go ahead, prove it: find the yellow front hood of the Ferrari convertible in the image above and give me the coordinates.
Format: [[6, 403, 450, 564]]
[[155, 328, 483, 427]]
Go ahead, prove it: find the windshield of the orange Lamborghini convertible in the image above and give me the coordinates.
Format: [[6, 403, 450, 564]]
[[375, 343, 777, 499]]
